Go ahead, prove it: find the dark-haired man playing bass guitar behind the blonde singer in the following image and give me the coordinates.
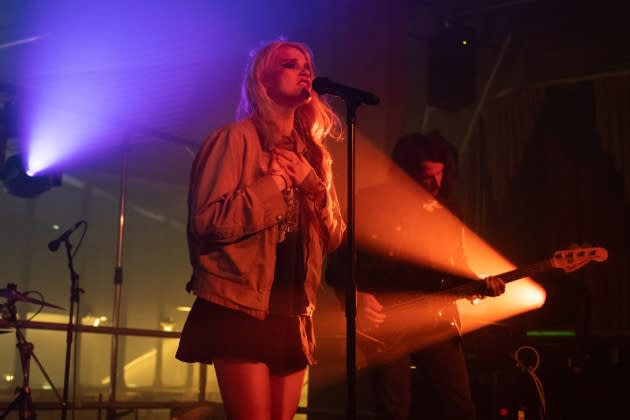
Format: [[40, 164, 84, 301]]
[[327, 133, 505, 419]]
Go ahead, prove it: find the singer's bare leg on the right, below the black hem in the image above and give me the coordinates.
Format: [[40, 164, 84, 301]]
[[271, 369, 306, 420]]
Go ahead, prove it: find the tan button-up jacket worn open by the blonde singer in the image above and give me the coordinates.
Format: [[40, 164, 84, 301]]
[[188, 120, 345, 319]]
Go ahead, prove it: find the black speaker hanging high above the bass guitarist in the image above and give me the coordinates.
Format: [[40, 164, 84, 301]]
[[427, 22, 477, 111]]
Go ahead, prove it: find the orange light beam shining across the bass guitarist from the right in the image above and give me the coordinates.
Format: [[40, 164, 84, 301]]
[[355, 138, 546, 364]]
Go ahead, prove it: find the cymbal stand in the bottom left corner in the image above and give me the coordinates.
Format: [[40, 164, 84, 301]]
[[0, 290, 61, 420]]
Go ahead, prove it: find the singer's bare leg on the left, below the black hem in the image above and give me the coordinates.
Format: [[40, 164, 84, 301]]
[[214, 359, 272, 420]]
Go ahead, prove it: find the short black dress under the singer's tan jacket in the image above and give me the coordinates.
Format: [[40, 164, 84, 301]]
[[175, 225, 312, 373]]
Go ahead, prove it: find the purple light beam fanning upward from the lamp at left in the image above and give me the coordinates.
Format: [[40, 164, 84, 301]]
[[9, 0, 313, 177]]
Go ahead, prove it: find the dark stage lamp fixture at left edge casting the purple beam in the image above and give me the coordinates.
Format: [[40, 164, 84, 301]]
[[2, 154, 61, 198]]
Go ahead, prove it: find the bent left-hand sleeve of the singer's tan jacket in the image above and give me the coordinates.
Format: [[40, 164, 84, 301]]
[[188, 125, 287, 244]]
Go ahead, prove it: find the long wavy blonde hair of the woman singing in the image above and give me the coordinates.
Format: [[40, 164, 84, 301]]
[[236, 40, 342, 190]]
